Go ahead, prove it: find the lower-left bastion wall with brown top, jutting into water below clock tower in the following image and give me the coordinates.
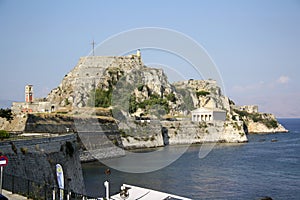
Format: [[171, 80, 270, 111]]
[[24, 114, 124, 161]]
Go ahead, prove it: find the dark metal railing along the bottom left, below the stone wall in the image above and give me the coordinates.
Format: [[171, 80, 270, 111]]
[[3, 173, 97, 200]]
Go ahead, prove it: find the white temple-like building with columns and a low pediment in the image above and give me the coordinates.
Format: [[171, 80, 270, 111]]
[[191, 107, 226, 122]]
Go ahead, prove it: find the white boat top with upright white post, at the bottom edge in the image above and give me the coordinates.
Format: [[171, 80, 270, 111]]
[[99, 182, 191, 200]]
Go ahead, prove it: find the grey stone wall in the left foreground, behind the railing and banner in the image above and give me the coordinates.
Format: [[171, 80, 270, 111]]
[[0, 134, 85, 194]]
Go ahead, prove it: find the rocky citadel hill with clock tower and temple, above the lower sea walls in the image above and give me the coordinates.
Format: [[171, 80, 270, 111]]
[[6, 50, 283, 138]]
